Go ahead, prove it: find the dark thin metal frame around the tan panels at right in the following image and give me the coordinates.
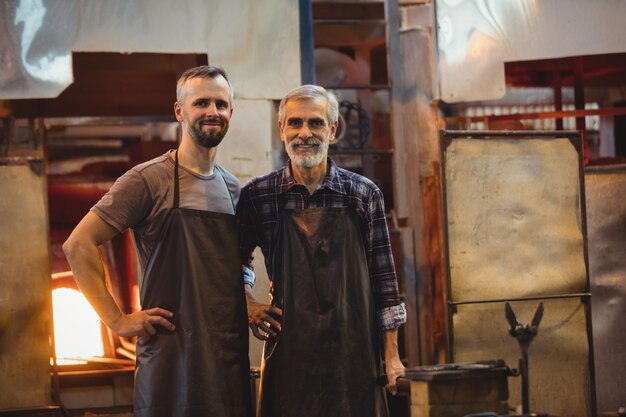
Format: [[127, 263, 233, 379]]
[[439, 130, 597, 417]]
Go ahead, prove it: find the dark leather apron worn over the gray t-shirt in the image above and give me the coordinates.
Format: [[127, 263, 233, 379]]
[[134, 152, 252, 417]]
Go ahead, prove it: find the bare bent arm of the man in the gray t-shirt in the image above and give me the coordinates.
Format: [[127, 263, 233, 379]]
[[63, 211, 174, 343]]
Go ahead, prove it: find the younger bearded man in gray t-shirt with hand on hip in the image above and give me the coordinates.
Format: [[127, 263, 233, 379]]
[[63, 66, 252, 417]]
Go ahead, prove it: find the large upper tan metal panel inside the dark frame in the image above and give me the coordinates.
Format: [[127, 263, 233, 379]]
[[445, 138, 587, 301]]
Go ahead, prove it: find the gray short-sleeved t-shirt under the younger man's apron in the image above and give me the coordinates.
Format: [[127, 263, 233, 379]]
[[91, 151, 240, 275]]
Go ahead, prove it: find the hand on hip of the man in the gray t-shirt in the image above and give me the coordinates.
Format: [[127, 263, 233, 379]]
[[111, 307, 175, 345]]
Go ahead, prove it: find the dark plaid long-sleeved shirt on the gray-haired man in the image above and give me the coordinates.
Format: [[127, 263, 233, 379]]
[[237, 159, 406, 330]]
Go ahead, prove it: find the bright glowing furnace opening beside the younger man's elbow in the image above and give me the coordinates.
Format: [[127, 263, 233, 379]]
[[52, 288, 104, 365]]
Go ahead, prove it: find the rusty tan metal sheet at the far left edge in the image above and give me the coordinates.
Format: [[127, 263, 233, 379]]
[[0, 158, 52, 410]]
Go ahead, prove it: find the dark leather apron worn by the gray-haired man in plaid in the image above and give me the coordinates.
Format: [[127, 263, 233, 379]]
[[257, 208, 387, 417]]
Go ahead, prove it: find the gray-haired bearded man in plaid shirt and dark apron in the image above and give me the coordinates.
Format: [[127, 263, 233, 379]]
[[237, 85, 406, 417]]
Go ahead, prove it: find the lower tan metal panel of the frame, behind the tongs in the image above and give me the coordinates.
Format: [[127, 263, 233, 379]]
[[453, 298, 591, 417]]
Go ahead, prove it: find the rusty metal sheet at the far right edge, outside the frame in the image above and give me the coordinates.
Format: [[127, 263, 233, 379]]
[[585, 167, 626, 412]]
